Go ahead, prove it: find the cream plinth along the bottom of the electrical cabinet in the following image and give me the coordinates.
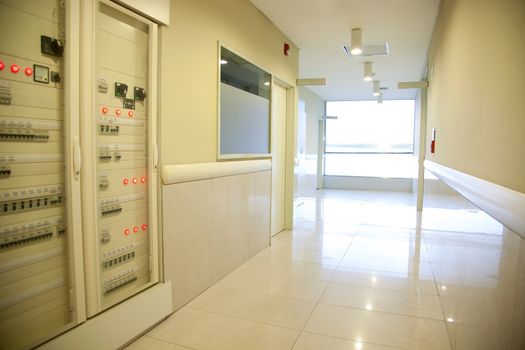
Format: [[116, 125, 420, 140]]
[[38, 282, 173, 350]]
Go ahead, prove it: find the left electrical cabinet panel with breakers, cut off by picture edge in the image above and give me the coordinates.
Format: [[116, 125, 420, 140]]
[[0, 0, 76, 349]]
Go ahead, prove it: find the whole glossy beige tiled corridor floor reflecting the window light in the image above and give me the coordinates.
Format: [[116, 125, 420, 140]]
[[129, 190, 525, 350]]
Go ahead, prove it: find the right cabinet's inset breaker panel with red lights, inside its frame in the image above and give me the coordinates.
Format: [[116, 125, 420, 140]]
[[93, 3, 152, 309]]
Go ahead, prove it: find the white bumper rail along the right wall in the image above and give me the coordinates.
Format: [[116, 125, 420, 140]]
[[425, 160, 525, 238]]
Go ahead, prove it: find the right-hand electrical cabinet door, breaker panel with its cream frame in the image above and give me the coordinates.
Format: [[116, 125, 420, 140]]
[[82, 2, 158, 316]]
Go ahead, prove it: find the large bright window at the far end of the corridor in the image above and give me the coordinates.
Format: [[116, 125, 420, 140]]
[[325, 100, 417, 178]]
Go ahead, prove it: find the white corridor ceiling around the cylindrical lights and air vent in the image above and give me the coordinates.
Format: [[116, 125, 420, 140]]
[[250, 0, 440, 101]]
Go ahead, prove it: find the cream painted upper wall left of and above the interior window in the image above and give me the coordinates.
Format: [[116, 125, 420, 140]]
[[160, 0, 298, 165]]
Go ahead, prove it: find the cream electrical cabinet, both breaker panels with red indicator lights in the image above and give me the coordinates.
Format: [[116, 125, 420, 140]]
[[0, 0, 159, 349]]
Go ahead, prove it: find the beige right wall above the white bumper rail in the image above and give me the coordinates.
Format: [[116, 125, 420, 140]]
[[427, 0, 525, 192]]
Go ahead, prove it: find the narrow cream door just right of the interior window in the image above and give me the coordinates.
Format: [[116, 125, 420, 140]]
[[270, 83, 287, 236]]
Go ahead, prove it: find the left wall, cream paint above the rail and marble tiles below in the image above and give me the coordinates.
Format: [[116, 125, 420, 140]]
[[159, 0, 298, 309]]
